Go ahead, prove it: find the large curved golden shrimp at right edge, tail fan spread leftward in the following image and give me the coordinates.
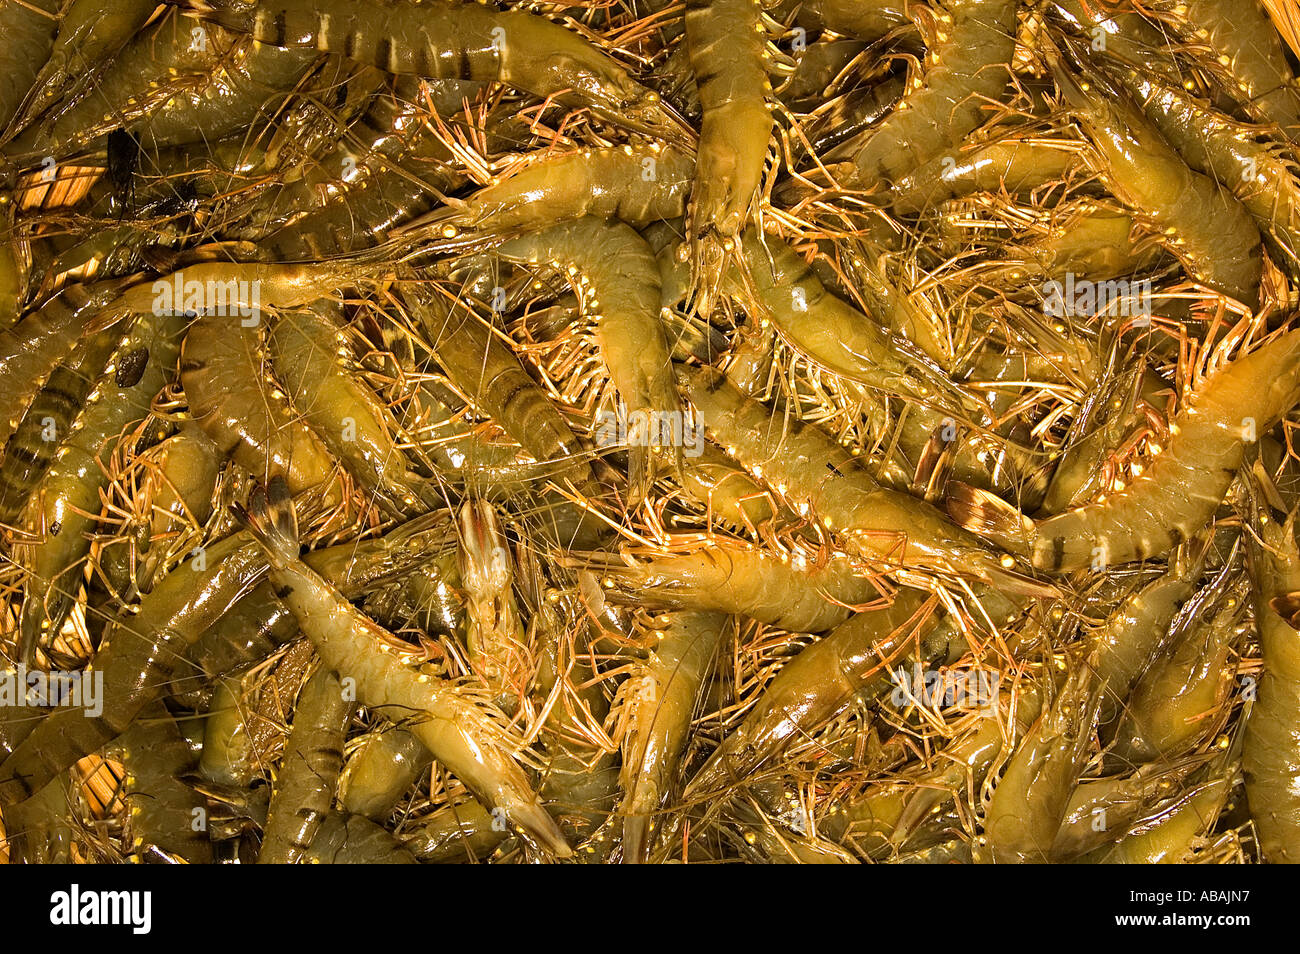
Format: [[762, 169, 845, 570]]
[[967, 330, 1300, 572]]
